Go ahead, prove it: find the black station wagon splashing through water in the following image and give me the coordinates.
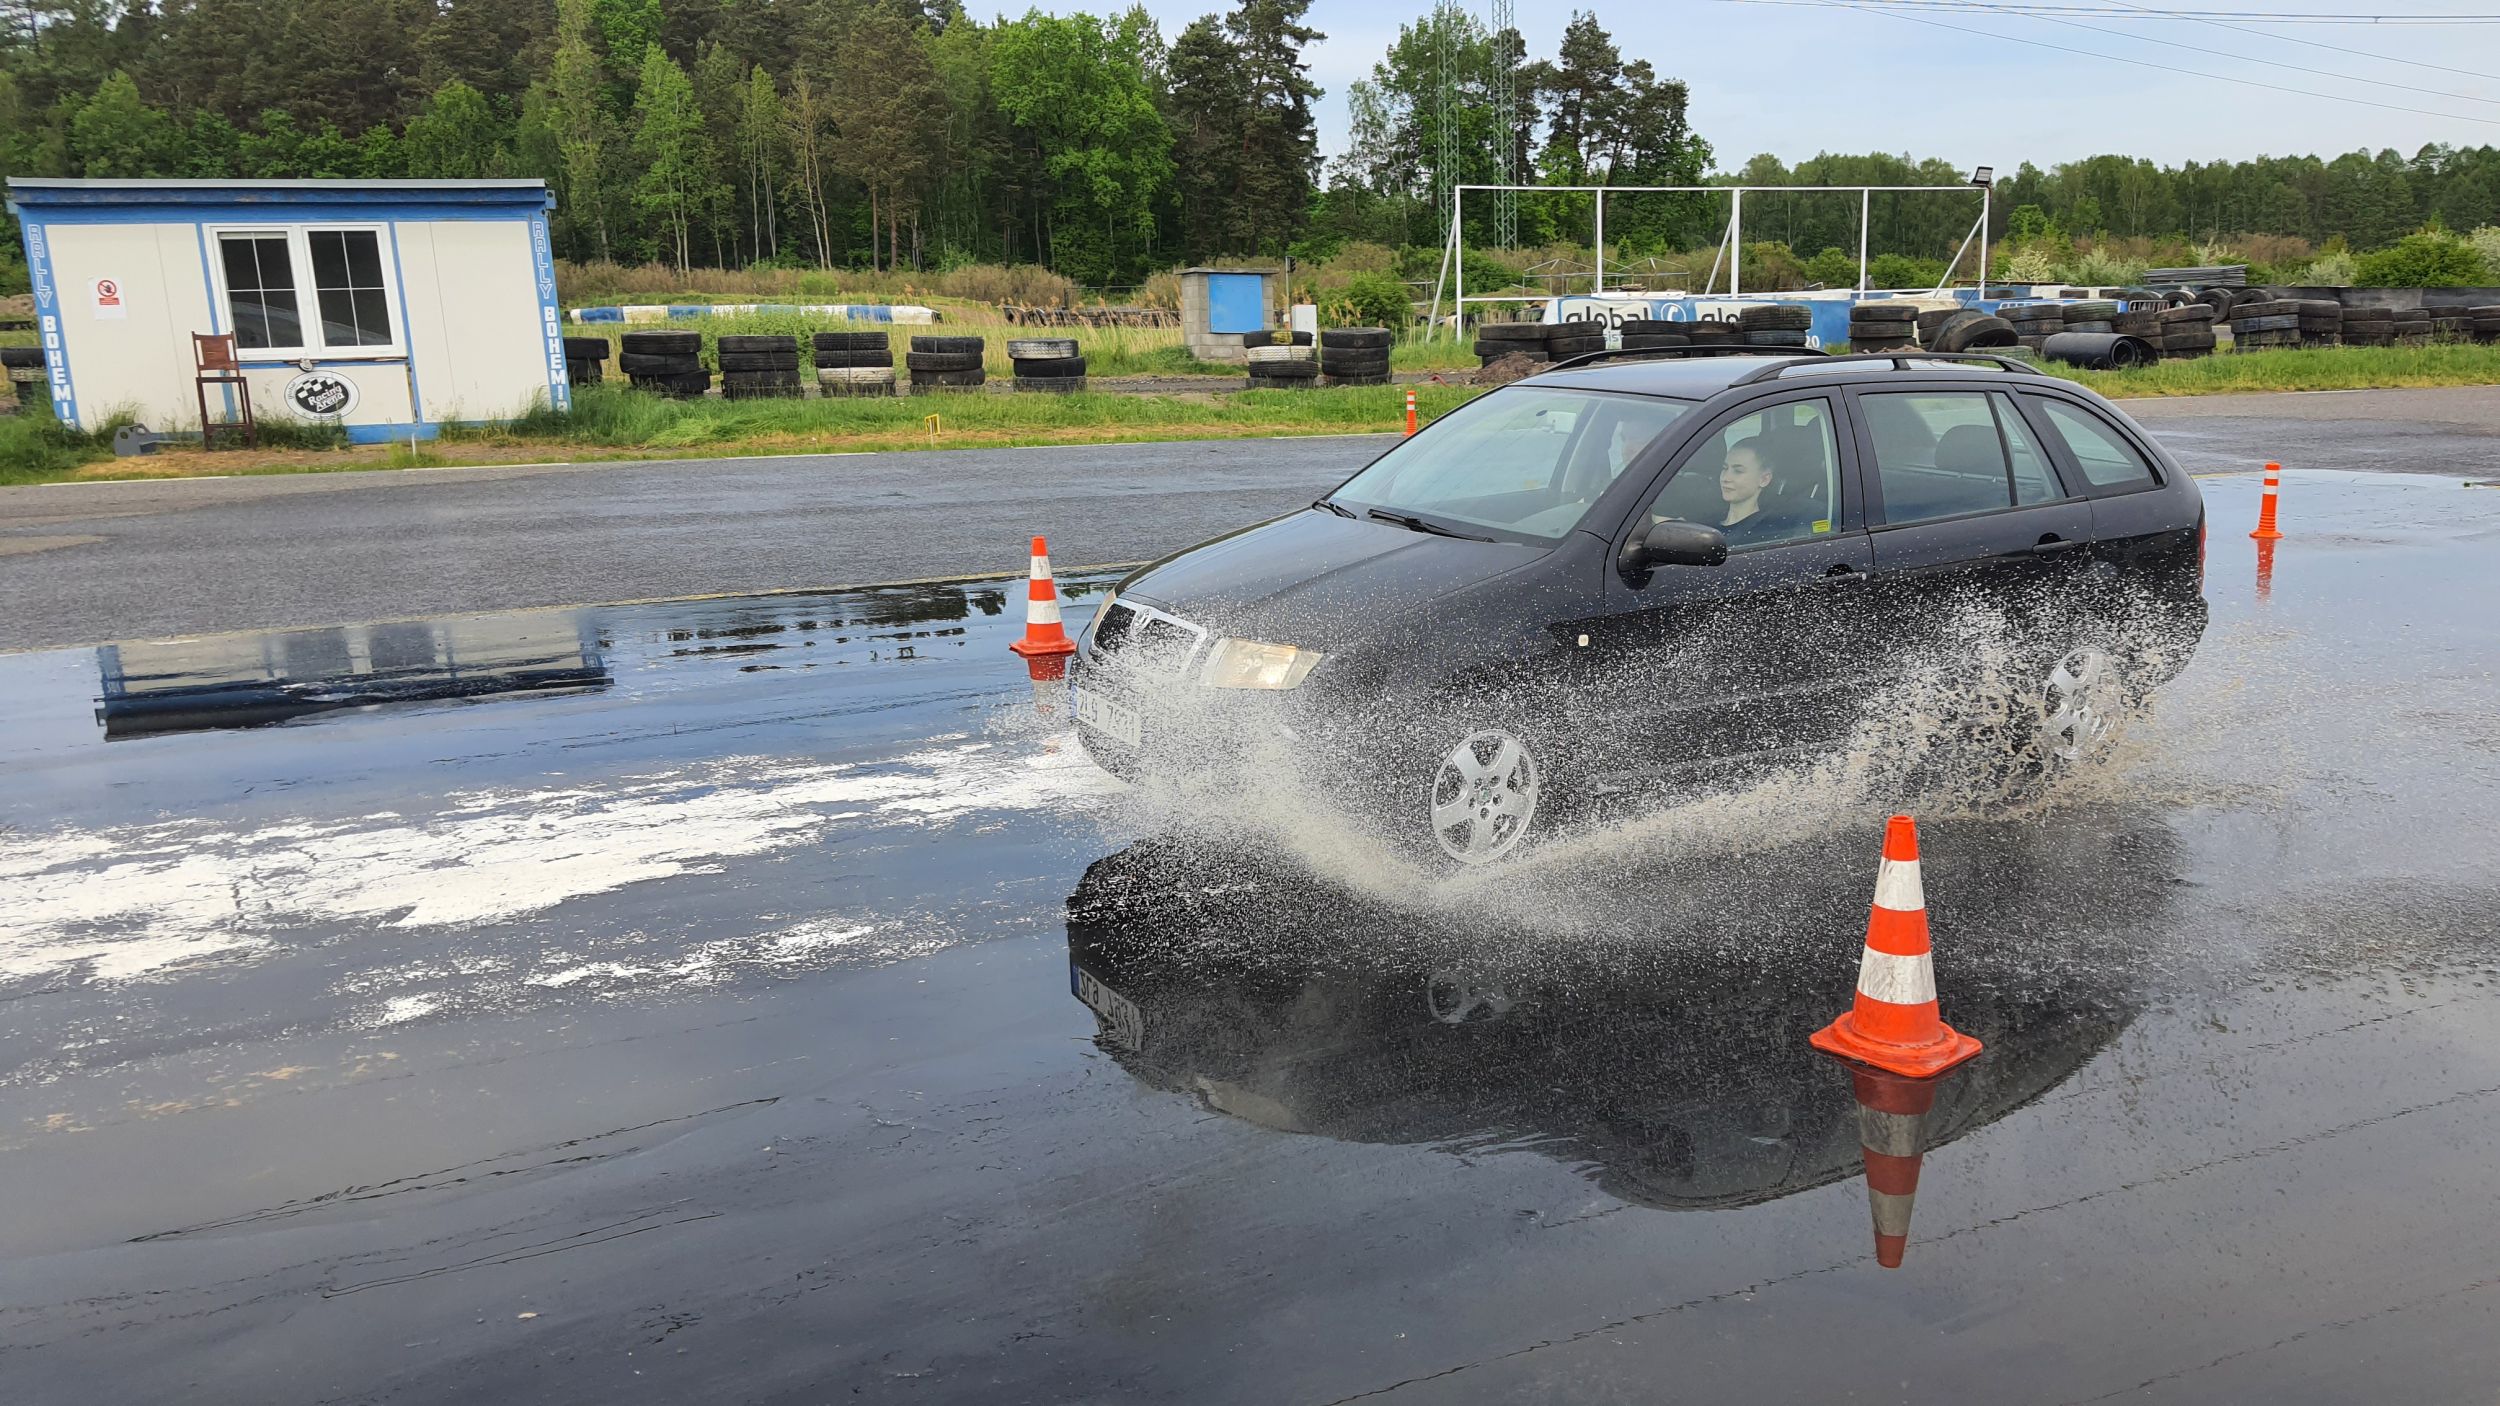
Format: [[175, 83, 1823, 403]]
[[1073, 353, 2205, 863]]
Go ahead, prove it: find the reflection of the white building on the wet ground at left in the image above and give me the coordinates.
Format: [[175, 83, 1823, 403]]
[[95, 615, 608, 741]]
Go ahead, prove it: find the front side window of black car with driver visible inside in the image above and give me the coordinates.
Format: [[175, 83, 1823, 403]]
[[1650, 398, 1840, 550]]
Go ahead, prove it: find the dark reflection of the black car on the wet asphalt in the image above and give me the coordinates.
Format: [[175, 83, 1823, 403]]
[[1068, 826, 2175, 1208]]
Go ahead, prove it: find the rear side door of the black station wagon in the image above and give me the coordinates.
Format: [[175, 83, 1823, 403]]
[[1850, 383, 2093, 665]]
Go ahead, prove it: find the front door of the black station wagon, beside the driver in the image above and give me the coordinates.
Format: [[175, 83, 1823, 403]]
[[1580, 390, 1873, 776]]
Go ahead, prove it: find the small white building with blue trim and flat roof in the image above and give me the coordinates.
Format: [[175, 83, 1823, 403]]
[[8, 178, 568, 443]]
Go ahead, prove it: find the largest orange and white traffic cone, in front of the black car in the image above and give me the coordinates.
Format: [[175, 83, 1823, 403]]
[[1808, 816, 1980, 1078]]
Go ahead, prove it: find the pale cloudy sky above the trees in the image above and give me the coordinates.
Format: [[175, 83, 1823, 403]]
[[1005, 0, 2500, 168]]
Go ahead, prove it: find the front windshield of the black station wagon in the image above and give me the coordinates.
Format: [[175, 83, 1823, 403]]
[[1335, 385, 1693, 543]]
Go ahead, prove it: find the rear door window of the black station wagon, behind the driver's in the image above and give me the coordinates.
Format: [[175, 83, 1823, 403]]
[[1858, 390, 2065, 525]]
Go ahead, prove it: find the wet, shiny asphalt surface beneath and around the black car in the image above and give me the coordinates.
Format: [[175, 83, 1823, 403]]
[[0, 460, 2500, 1406]]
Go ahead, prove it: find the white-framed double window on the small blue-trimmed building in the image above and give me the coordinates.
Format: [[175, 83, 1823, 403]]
[[218, 225, 400, 355]]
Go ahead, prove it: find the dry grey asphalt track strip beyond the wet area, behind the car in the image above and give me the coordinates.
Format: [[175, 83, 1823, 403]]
[[0, 388, 2500, 650]]
